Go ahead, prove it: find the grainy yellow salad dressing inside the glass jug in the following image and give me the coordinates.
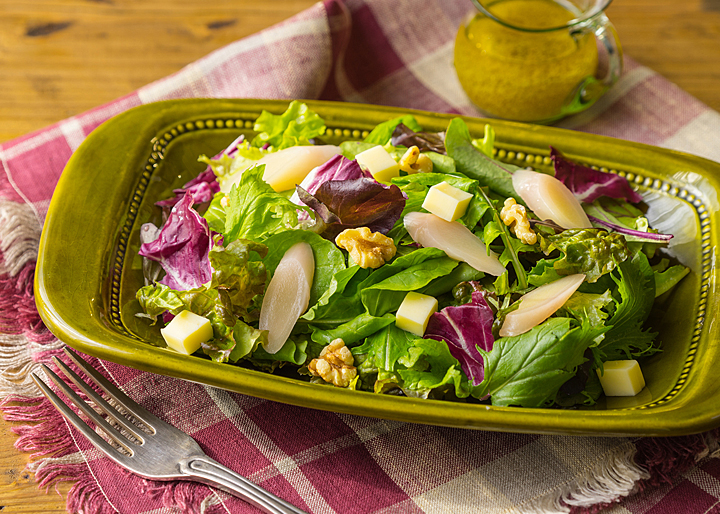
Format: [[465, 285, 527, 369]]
[[455, 0, 598, 122]]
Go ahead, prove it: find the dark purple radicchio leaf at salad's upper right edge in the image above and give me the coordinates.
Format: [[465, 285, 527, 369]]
[[550, 146, 642, 203]]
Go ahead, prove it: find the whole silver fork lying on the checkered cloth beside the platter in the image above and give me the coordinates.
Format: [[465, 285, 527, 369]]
[[32, 348, 307, 514]]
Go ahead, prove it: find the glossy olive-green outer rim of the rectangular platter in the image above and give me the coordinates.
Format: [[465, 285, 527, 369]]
[[35, 99, 720, 436]]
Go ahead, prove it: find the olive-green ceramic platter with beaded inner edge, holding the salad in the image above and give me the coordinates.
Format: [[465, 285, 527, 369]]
[[35, 100, 720, 436]]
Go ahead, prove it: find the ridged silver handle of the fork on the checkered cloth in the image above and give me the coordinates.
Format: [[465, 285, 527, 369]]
[[180, 456, 307, 514]]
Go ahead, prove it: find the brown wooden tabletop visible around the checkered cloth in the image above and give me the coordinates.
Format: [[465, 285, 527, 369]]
[[0, 0, 720, 514]]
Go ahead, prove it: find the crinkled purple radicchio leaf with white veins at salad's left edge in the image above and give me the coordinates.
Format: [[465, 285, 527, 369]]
[[138, 193, 213, 291]]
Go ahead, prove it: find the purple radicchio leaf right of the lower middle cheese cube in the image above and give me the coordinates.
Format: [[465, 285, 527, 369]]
[[424, 291, 495, 386]]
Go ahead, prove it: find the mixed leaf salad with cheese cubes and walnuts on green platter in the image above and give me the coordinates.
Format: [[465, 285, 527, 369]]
[[132, 101, 689, 407]]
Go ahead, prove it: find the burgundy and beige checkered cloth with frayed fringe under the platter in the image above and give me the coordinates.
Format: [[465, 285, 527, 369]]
[[0, 0, 720, 514]]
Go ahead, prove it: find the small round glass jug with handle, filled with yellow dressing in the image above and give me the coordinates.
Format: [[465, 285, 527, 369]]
[[455, 0, 622, 123]]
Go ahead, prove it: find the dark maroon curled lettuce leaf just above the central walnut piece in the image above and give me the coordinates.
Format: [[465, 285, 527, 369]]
[[296, 178, 405, 239]]
